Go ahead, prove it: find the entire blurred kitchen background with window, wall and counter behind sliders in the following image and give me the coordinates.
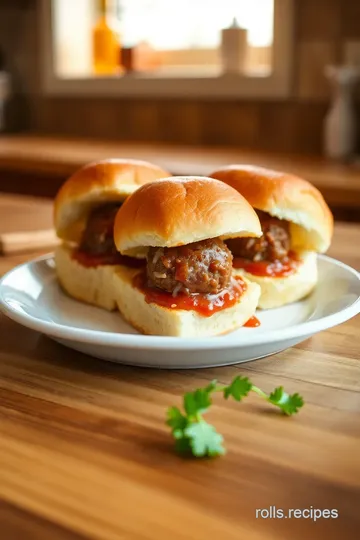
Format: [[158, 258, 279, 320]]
[[0, 0, 360, 220]]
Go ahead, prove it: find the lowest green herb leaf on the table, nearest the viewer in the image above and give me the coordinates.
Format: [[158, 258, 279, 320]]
[[184, 420, 225, 457]]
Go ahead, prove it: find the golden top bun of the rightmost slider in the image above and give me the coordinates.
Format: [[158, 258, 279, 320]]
[[210, 165, 333, 253]]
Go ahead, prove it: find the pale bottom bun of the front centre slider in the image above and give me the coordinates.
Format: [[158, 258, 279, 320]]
[[114, 267, 260, 337]]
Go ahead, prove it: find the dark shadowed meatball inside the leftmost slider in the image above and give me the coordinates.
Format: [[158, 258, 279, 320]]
[[79, 203, 121, 255]]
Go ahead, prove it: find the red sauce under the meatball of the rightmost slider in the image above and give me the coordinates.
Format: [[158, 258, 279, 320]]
[[233, 251, 301, 278]]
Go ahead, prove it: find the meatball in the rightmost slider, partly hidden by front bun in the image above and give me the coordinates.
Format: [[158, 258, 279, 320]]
[[226, 212, 290, 262]]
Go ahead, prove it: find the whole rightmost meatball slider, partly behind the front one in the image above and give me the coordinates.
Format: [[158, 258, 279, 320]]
[[211, 165, 333, 309]]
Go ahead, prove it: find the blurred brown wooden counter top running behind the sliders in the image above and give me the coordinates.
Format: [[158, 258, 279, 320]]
[[0, 136, 360, 212]]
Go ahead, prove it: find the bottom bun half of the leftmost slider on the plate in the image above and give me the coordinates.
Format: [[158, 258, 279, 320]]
[[55, 245, 118, 311]]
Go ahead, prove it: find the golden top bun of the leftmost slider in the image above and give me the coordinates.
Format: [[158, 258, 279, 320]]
[[54, 159, 169, 242]]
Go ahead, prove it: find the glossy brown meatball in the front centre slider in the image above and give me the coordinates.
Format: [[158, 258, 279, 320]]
[[147, 238, 232, 296]]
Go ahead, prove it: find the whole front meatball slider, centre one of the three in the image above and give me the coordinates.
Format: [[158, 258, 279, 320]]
[[114, 177, 261, 337]]
